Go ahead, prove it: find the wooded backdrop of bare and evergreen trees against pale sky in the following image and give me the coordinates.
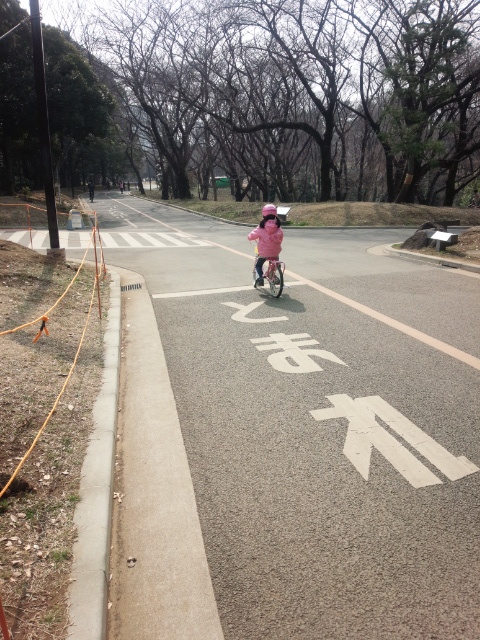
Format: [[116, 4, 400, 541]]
[[0, 0, 480, 206]]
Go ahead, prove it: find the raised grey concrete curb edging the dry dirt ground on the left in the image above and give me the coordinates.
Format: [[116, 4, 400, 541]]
[[68, 271, 121, 640]]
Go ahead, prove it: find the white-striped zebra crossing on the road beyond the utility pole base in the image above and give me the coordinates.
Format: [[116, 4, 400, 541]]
[[0, 229, 212, 251]]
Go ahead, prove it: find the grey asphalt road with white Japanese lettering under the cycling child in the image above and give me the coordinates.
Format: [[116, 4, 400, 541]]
[[30, 197, 480, 640]]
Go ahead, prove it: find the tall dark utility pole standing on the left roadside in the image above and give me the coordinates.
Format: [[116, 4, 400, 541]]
[[30, 0, 65, 256]]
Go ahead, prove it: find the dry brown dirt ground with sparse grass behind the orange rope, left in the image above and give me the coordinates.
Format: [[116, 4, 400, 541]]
[[0, 240, 109, 640]]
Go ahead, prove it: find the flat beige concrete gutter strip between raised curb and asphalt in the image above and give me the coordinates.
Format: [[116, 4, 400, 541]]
[[105, 267, 224, 640]]
